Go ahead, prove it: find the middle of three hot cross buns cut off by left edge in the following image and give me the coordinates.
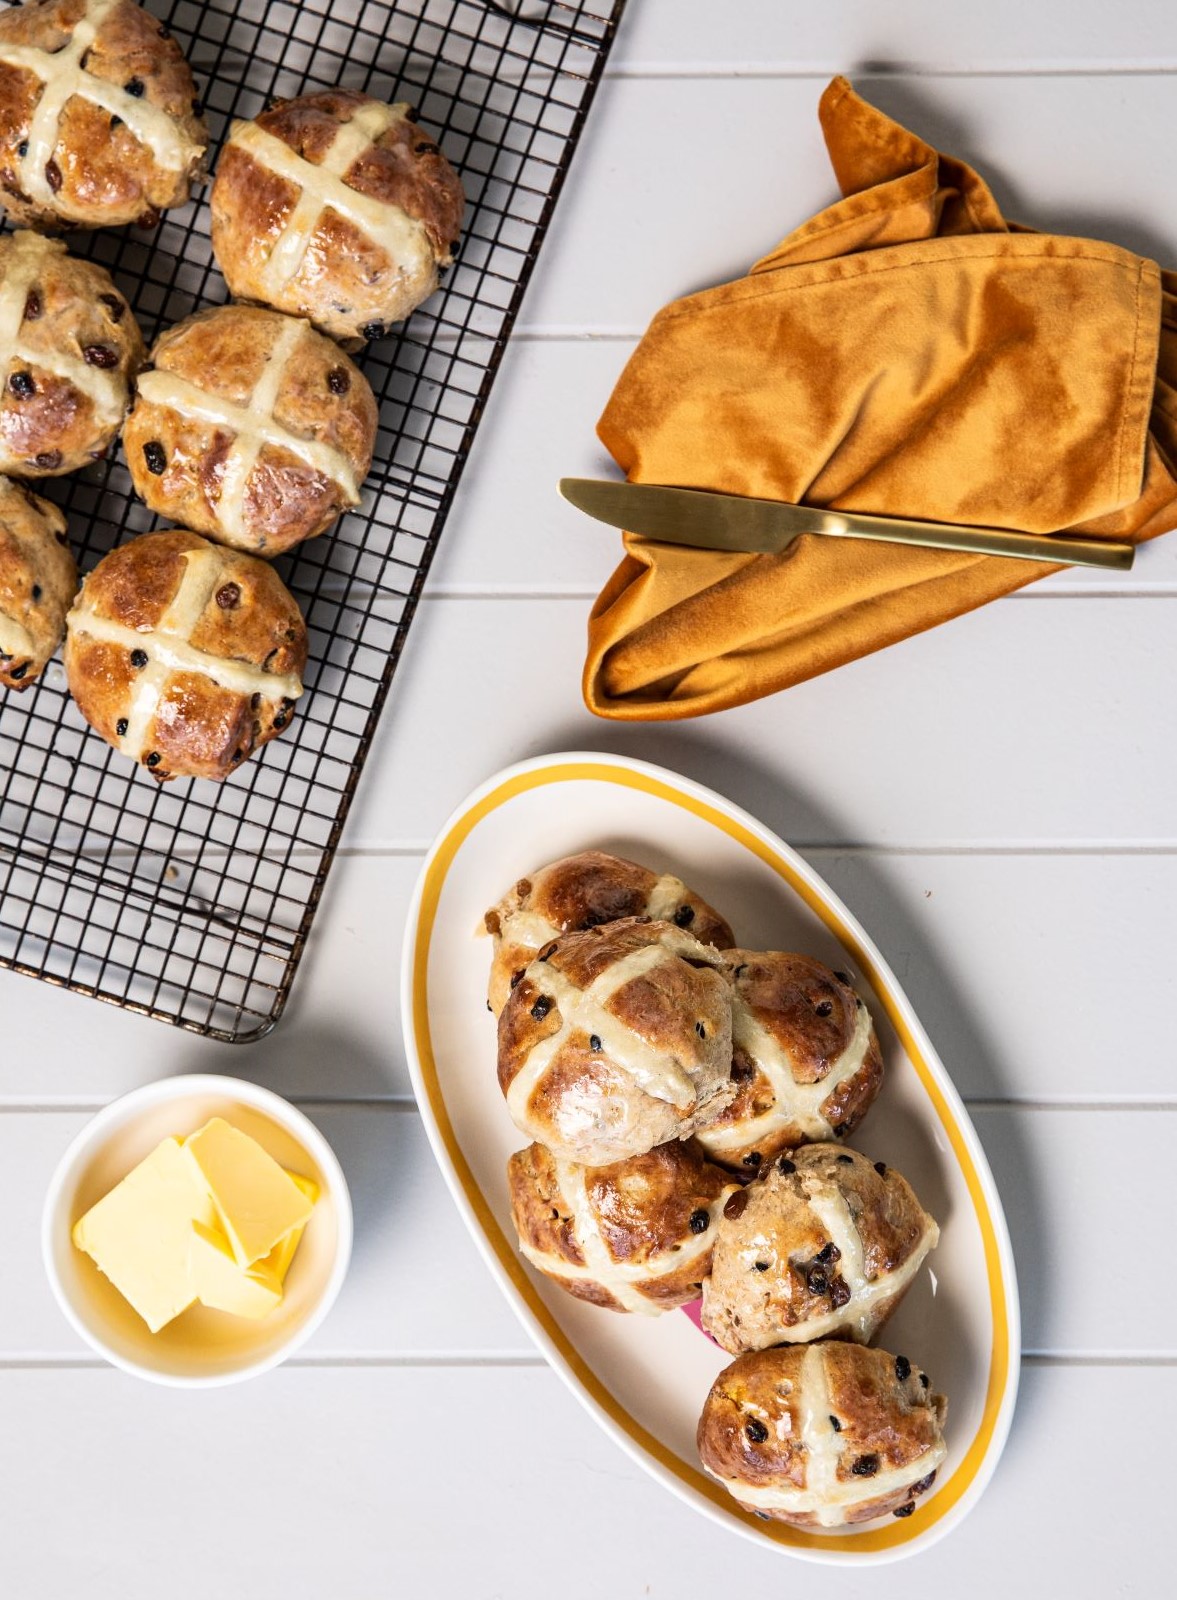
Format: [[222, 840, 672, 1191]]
[[0, 232, 142, 478]]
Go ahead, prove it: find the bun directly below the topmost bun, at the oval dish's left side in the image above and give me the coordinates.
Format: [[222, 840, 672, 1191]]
[[507, 1141, 737, 1315]]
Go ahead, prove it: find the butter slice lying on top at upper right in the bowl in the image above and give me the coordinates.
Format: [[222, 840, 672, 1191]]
[[184, 1117, 312, 1267]]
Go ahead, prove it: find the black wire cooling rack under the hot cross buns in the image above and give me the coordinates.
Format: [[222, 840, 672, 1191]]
[[0, 0, 624, 1042]]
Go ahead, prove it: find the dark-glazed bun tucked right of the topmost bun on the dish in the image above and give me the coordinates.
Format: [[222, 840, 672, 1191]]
[[700, 950, 883, 1173]]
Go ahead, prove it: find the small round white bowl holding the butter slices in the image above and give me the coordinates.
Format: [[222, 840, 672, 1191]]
[[42, 1074, 352, 1389]]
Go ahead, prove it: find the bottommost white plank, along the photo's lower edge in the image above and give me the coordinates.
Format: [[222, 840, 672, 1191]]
[[0, 1366, 1177, 1600]]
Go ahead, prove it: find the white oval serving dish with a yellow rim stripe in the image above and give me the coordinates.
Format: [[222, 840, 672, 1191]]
[[401, 754, 1020, 1566]]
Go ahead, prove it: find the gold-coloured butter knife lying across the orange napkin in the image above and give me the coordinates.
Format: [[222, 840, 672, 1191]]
[[560, 478, 1135, 571]]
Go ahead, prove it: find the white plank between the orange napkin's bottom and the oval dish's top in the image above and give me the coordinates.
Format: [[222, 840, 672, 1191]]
[[345, 597, 1177, 848]]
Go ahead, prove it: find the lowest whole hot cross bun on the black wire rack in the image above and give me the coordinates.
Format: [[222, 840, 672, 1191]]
[[66, 530, 307, 781]]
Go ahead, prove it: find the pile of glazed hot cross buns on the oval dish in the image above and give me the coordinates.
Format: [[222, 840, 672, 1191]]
[[485, 850, 945, 1528]]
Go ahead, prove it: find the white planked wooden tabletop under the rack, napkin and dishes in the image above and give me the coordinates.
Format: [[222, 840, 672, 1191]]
[[0, 0, 1177, 1600]]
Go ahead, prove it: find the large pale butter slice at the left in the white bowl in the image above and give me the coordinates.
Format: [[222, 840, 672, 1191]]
[[74, 1139, 216, 1333]]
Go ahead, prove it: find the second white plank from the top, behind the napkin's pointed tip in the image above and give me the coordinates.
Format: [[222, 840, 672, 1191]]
[[521, 76, 1177, 334]]
